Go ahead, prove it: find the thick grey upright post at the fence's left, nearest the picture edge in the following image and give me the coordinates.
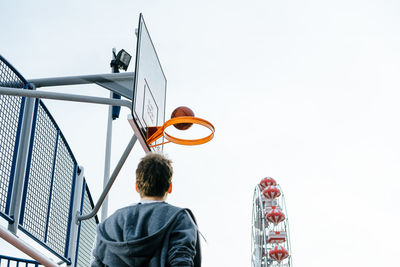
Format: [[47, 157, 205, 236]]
[[8, 93, 35, 234]]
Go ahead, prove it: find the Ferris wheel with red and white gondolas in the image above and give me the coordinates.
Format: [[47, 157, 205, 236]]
[[251, 177, 292, 267]]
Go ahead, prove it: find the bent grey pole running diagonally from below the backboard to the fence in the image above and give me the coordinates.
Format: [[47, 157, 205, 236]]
[[78, 135, 137, 221]]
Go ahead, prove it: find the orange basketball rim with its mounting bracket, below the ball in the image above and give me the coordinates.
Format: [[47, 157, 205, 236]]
[[147, 117, 215, 147]]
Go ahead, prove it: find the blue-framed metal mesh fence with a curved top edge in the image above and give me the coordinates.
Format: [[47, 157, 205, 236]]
[[0, 55, 98, 266]]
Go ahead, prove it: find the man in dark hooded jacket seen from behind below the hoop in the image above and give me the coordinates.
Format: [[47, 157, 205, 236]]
[[92, 153, 201, 267]]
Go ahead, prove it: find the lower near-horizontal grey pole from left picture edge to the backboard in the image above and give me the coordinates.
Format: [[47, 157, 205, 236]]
[[0, 86, 132, 109]]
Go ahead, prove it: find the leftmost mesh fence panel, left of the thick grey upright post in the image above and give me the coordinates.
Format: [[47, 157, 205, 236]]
[[0, 55, 27, 222]]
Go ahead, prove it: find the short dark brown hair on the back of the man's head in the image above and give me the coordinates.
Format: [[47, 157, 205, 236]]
[[136, 153, 173, 197]]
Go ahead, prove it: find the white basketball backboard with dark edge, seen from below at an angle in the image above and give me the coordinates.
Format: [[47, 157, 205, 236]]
[[130, 14, 167, 152]]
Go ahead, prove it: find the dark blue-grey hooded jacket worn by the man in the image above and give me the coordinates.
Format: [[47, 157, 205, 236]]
[[92, 202, 201, 267]]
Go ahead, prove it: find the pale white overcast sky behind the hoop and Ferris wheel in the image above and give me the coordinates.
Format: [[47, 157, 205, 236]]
[[0, 0, 400, 267]]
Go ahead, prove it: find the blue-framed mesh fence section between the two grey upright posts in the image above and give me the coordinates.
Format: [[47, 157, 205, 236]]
[[19, 100, 77, 262]]
